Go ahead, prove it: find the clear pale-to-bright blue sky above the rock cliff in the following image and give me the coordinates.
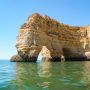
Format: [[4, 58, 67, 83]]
[[0, 0, 90, 59]]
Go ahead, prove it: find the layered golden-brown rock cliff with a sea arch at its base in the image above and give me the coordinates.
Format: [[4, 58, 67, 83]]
[[11, 13, 90, 61]]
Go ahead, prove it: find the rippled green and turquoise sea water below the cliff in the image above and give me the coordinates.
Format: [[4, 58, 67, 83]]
[[0, 60, 90, 90]]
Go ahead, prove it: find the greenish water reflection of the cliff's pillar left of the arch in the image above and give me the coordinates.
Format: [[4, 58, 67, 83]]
[[12, 63, 37, 90]]
